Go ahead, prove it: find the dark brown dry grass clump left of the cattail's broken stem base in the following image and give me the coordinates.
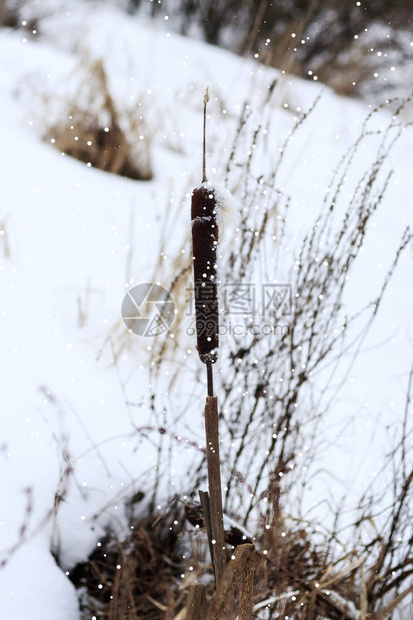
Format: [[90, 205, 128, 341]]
[[69, 511, 187, 620]]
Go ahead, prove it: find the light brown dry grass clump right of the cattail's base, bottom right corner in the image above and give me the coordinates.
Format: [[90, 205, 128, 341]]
[[253, 462, 413, 620]]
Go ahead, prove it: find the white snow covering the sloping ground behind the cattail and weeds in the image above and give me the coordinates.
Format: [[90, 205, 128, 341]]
[[0, 4, 413, 620]]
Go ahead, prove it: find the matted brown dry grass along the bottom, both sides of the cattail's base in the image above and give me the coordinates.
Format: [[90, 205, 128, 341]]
[[69, 492, 411, 620]]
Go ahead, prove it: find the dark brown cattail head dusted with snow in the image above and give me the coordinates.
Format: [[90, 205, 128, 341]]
[[191, 182, 219, 364]]
